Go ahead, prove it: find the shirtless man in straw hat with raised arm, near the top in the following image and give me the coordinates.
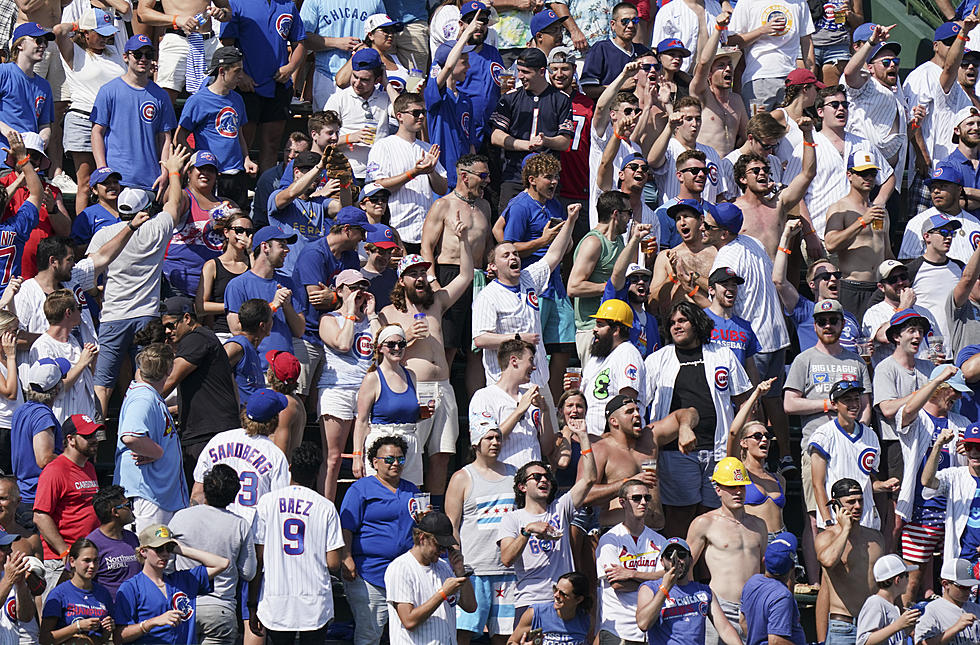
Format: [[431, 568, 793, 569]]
[[690, 11, 749, 157]]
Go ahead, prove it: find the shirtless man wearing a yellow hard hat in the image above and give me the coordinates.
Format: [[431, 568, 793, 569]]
[[687, 457, 768, 645]]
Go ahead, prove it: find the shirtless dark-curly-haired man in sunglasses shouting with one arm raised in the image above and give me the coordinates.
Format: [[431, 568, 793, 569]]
[[734, 117, 821, 260]]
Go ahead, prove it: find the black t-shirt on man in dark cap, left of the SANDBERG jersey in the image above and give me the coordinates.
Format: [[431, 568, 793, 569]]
[[177, 326, 241, 446]]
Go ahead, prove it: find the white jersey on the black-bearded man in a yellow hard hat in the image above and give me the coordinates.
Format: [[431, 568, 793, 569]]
[[582, 341, 646, 437]]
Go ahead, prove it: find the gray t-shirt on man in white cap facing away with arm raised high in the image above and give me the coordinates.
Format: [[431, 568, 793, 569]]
[[88, 212, 174, 322]]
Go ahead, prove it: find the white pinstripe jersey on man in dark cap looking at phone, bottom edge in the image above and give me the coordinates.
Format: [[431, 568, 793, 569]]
[[385, 551, 459, 645]]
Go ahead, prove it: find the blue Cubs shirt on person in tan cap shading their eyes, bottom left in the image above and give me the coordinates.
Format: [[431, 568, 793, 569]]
[[112, 565, 212, 645]]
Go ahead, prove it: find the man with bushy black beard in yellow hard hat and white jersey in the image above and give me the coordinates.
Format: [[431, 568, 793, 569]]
[[582, 300, 646, 437]]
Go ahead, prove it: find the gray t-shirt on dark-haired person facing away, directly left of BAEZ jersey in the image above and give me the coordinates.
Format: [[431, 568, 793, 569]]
[[167, 504, 256, 610]]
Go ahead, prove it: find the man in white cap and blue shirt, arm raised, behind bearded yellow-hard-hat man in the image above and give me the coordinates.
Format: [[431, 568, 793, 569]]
[[600, 224, 660, 358]]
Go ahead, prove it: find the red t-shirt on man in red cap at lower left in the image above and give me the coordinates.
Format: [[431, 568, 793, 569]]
[[34, 455, 99, 560]]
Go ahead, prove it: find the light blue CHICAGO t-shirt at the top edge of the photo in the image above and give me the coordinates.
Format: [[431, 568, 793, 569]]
[[299, 0, 384, 78]]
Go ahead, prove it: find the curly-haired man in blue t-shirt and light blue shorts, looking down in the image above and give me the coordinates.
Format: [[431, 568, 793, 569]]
[[493, 154, 575, 400]]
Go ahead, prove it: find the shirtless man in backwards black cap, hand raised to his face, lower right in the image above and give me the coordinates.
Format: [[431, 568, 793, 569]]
[[815, 478, 885, 643]]
